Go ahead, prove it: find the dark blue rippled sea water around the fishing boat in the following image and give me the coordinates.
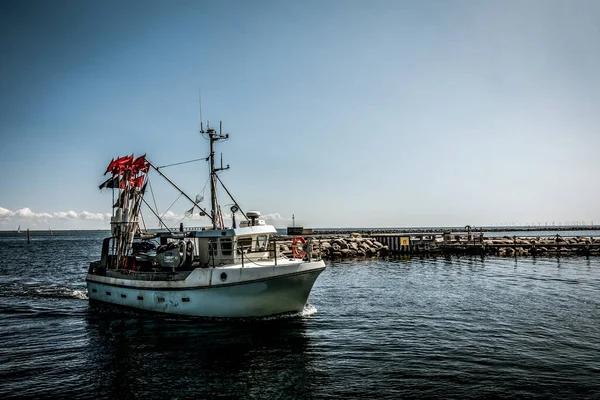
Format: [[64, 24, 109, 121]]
[[0, 232, 600, 399]]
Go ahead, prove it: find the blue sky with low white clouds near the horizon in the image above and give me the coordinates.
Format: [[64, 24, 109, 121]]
[[0, 0, 600, 230]]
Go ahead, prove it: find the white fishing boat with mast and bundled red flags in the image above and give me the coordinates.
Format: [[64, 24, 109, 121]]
[[86, 123, 325, 318]]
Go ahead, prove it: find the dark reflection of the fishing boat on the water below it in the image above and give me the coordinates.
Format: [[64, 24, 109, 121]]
[[86, 307, 318, 398]]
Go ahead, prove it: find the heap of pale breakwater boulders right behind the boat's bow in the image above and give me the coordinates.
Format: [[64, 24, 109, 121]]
[[279, 233, 389, 259]]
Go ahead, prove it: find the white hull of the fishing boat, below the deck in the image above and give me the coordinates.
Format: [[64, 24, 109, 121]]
[[86, 261, 325, 317]]
